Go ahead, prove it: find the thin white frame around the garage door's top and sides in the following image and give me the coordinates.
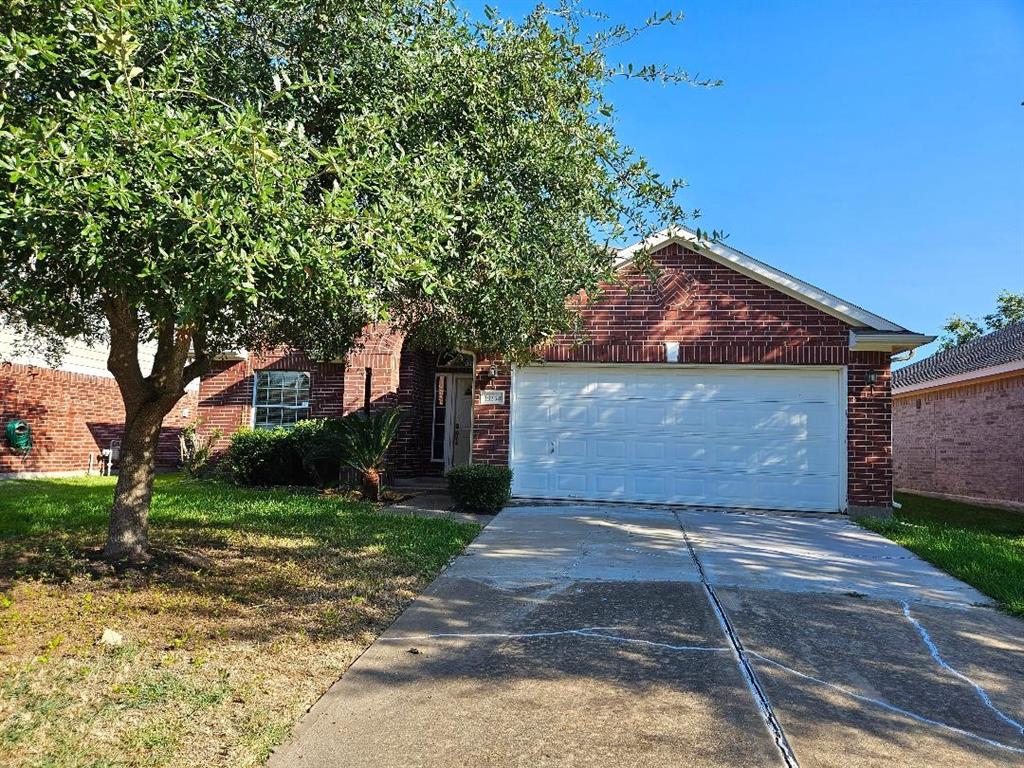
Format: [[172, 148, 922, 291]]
[[508, 361, 850, 512]]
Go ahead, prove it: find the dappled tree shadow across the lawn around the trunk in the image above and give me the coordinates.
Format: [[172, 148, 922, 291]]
[[0, 477, 477, 642]]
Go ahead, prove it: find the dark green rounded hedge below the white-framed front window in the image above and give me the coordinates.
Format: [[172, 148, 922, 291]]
[[223, 419, 341, 485]]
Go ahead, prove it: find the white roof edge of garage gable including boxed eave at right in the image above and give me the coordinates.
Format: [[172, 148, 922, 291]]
[[616, 226, 935, 352]]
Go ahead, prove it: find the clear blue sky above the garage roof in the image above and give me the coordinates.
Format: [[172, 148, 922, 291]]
[[460, 0, 1024, 356]]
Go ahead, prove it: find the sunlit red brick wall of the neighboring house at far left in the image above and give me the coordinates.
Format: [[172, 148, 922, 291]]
[[0, 362, 198, 473]]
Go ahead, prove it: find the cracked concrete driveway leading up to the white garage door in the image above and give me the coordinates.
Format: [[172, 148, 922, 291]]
[[270, 505, 1024, 768]]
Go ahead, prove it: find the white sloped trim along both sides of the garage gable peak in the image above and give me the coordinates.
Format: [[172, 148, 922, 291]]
[[615, 226, 906, 333]]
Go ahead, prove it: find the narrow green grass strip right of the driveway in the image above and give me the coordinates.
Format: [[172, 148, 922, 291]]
[[863, 494, 1024, 616]]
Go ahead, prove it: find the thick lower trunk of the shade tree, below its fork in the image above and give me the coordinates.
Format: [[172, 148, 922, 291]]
[[103, 401, 170, 563]]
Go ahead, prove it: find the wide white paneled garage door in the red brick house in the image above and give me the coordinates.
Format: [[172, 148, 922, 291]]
[[511, 366, 845, 511]]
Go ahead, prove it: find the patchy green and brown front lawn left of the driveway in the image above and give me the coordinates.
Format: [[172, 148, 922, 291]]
[[0, 476, 478, 768]]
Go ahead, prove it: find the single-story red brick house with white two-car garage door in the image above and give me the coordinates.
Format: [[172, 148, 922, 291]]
[[199, 228, 932, 518]]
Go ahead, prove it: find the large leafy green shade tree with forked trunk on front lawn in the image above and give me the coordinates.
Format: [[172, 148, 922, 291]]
[[0, 0, 712, 560]]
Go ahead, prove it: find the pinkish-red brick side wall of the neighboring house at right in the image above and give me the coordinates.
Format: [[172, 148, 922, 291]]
[[893, 376, 1024, 502]]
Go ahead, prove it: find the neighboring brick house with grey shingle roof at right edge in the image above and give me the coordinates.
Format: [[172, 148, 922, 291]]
[[893, 322, 1024, 509]]
